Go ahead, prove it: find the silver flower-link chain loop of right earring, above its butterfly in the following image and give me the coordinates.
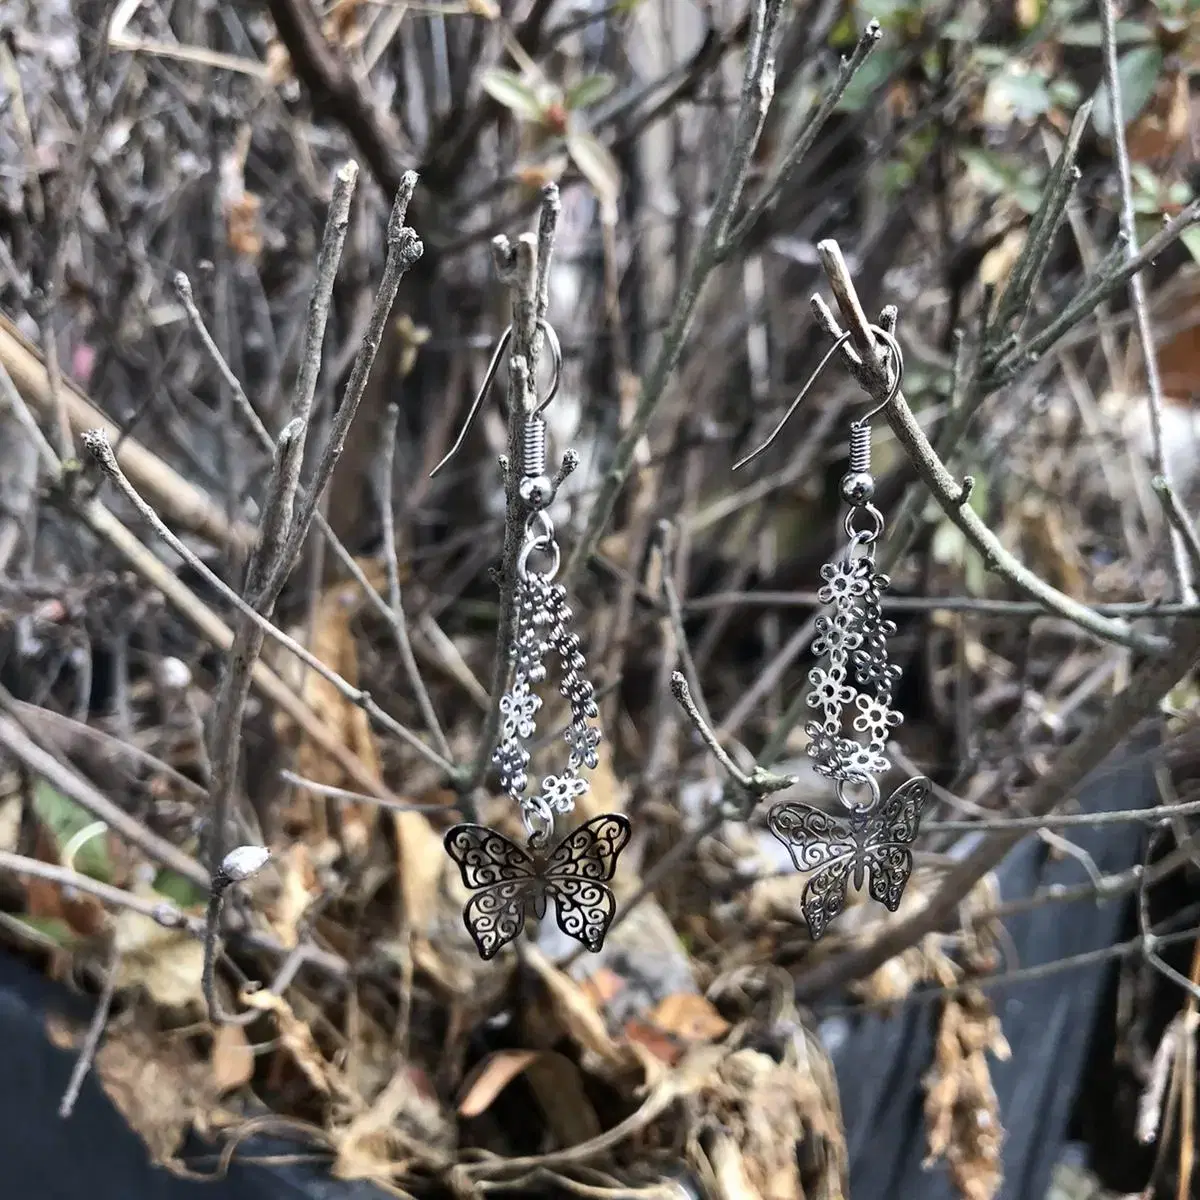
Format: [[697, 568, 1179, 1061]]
[[805, 549, 901, 781]]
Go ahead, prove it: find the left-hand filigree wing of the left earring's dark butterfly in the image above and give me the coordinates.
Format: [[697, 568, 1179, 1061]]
[[445, 824, 541, 960]]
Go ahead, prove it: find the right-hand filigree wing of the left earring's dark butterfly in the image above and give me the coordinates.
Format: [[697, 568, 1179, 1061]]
[[541, 812, 631, 953]]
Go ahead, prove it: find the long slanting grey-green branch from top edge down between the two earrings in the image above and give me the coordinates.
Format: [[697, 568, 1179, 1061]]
[[564, 0, 782, 580]]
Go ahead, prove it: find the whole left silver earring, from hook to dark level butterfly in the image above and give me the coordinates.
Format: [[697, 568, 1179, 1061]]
[[431, 320, 631, 959]]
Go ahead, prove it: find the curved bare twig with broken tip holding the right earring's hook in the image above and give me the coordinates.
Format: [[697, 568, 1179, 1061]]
[[812, 240, 1168, 654]]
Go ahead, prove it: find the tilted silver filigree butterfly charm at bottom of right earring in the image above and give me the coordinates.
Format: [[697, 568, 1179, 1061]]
[[767, 775, 930, 941]]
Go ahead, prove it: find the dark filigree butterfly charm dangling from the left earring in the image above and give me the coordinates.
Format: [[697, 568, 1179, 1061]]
[[445, 812, 631, 960]]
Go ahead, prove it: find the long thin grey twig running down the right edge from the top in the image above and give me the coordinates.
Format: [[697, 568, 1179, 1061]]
[[1099, 0, 1196, 604]]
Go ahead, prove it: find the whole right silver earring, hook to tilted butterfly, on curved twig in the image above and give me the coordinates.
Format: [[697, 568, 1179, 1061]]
[[733, 325, 930, 940]]
